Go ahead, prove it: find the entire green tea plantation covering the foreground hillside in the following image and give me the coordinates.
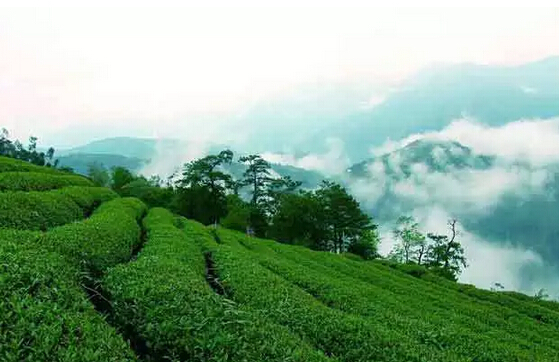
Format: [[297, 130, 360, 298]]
[[0, 158, 559, 362]]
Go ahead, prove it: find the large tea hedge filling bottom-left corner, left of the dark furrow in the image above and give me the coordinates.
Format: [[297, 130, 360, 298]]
[[0, 230, 135, 362]]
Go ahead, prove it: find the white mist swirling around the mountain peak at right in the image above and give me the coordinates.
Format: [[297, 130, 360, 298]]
[[349, 118, 559, 298]]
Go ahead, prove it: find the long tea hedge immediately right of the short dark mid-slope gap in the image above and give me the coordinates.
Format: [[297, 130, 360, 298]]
[[202, 231, 460, 361]]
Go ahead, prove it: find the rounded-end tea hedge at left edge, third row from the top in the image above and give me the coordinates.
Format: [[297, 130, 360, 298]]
[[0, 186, 117, 230]]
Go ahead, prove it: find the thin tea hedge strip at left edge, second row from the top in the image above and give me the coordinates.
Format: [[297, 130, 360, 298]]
[[0, 172, 93, 191]]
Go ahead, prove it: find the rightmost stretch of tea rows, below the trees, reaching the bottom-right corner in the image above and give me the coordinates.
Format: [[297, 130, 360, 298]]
[[219, 231, 559, 361]]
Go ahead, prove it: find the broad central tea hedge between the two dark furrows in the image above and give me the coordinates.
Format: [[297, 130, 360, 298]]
[[103, 208, 329, 361]]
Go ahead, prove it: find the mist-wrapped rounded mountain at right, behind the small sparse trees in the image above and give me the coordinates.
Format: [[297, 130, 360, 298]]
[[346, 140, 559, 263]]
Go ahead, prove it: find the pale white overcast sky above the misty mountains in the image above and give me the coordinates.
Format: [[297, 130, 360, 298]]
[[0, 1, 559, 146]]
